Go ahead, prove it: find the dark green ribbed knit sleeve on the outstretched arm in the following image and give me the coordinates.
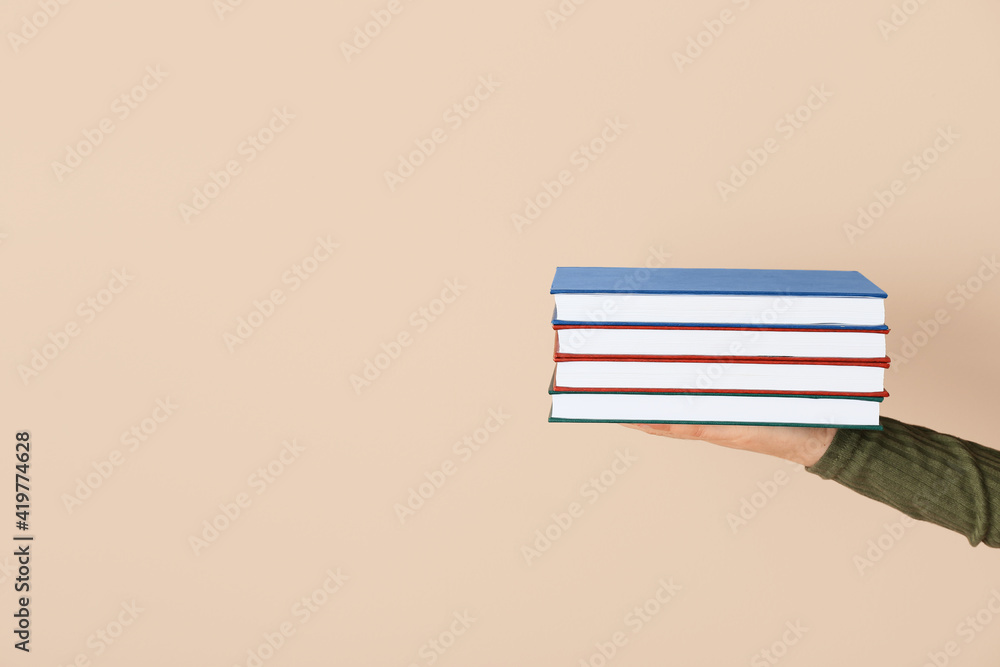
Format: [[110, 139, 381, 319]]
[[806, 417, 1000, 547]]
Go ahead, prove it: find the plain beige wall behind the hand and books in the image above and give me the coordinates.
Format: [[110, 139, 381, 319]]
[[0, 0, 1000, 667]]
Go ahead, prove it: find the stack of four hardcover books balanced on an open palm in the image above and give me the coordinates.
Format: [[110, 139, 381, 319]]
[[549, 267, 889, 429]]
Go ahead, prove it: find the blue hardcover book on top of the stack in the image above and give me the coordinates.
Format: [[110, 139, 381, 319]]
[[550, 267, 887, 330]]
